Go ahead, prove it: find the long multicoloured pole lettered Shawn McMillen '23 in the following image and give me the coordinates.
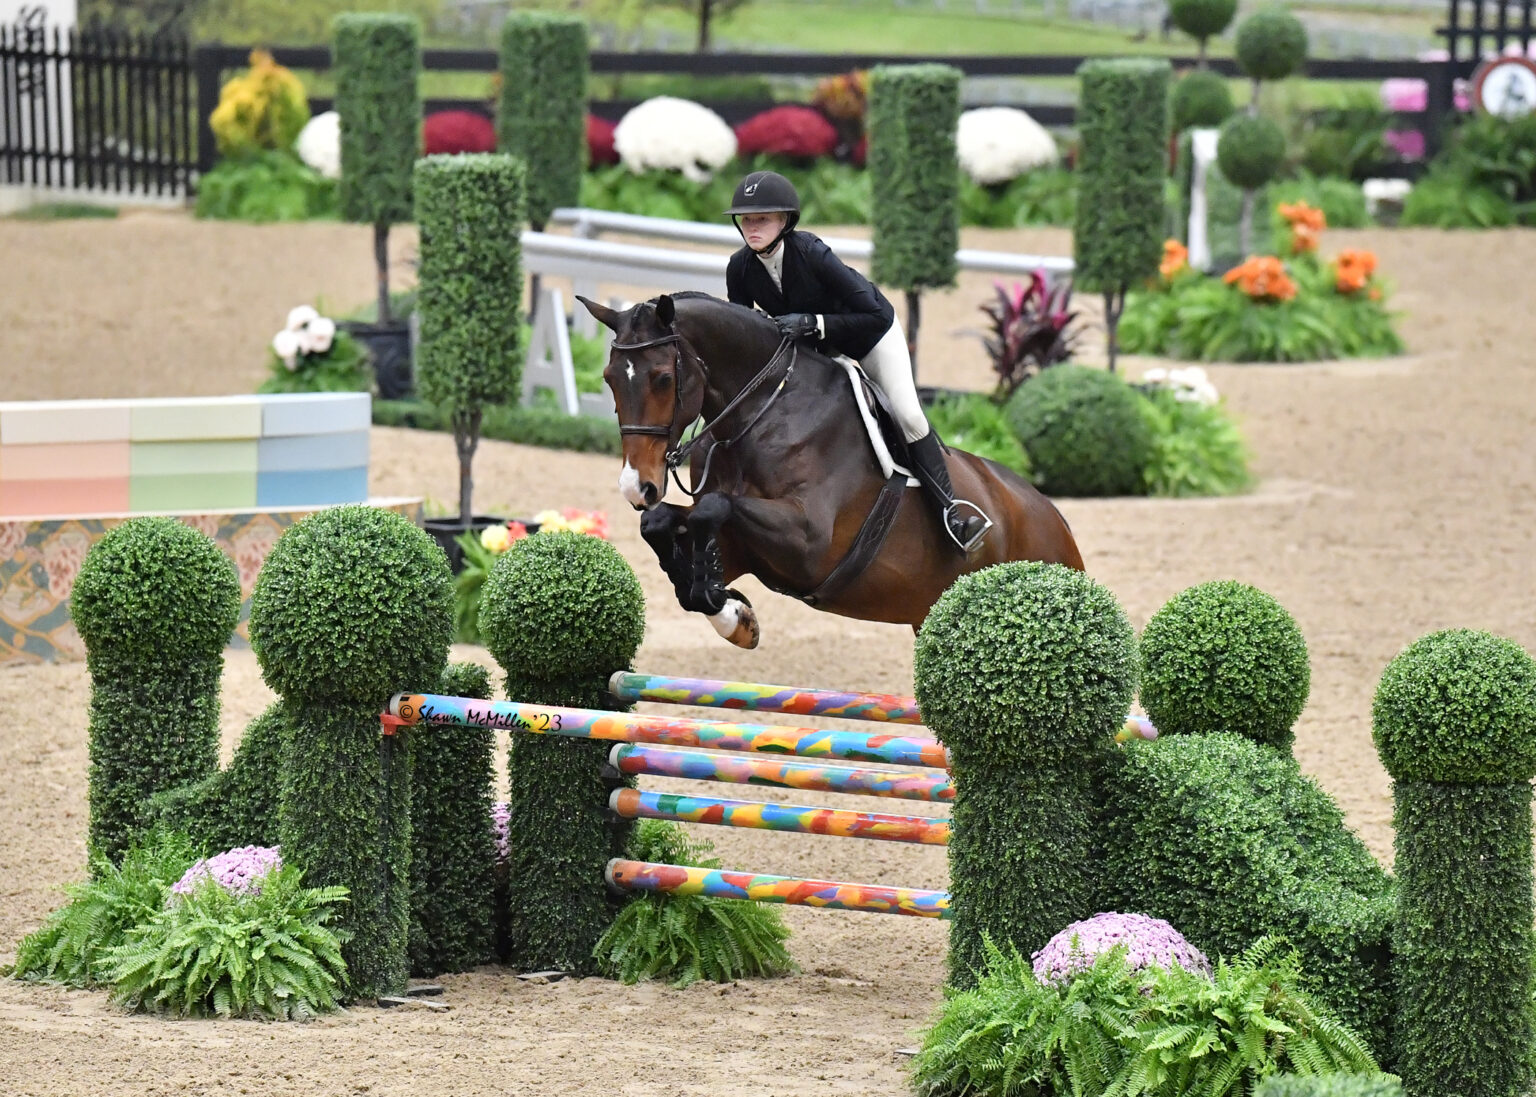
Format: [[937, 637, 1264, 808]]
[[390, 693, 949, 768]]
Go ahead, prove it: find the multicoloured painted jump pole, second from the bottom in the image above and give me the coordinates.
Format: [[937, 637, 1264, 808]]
[[608, 788, 949, 845]]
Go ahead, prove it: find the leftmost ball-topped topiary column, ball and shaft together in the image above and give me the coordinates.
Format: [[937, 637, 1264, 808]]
[[69, 518, 240, 862]]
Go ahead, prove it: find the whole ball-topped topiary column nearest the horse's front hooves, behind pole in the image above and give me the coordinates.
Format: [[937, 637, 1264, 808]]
[[481, 533, 645, 974]]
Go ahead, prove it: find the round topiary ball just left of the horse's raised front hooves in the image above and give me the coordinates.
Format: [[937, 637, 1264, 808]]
[[479, 533, 645, 684]]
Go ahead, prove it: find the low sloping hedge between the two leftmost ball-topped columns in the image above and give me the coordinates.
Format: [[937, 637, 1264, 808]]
[[144, 702, 290, 853]]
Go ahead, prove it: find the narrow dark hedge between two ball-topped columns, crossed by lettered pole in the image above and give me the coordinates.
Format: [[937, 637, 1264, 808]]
[[410, 662, 496, 976]]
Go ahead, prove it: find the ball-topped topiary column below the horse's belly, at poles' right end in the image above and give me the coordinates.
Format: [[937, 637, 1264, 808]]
[[914, 562, 1137, 988]]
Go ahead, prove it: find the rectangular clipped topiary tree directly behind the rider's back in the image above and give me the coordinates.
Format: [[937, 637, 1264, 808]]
[[868, 65, 960, 372]]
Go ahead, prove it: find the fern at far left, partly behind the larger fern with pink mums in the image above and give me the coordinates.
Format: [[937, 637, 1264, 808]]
[[11, 830, 198, 986]]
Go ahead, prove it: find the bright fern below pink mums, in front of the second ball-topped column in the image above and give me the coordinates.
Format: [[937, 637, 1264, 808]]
[[103, 865, 347, 1020]]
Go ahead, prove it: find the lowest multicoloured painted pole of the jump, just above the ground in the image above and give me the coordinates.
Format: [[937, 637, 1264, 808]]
[[604, 859, 949, 919]]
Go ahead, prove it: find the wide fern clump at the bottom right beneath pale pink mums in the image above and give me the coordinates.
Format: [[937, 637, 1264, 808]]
[[911, 939, 1378, 1097]]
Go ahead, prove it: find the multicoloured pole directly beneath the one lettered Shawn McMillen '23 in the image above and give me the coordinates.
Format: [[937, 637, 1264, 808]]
[[608, 744, 955, 804]]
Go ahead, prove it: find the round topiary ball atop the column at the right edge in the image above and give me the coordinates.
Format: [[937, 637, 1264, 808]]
[[1370, 628, 1536, 785]]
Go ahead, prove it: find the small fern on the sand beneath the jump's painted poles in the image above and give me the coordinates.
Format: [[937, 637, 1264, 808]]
[[593, 819, 797, 988]]
